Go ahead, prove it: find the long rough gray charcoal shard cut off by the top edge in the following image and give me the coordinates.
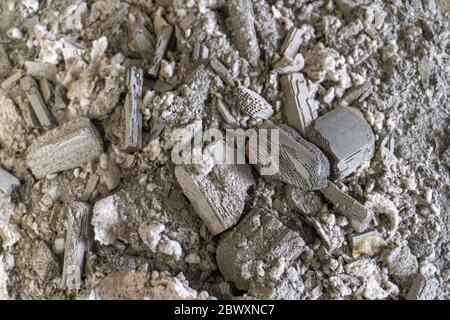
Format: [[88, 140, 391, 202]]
[[227, 0, 261, 66]]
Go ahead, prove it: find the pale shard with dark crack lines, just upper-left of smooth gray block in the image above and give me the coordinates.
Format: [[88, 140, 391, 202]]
[[280, 73, 317, 137]]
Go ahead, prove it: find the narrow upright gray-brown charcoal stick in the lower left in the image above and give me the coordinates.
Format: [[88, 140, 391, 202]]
[[61, 202, 93, 290]]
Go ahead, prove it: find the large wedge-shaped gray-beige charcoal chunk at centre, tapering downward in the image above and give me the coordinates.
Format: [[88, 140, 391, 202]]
[[175, 164, 255, 235]]
